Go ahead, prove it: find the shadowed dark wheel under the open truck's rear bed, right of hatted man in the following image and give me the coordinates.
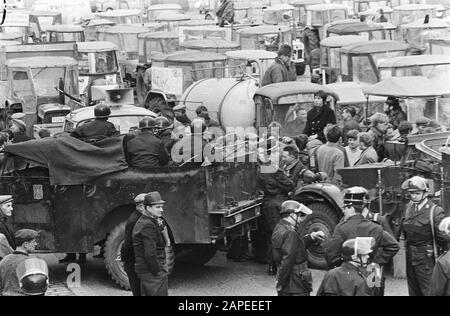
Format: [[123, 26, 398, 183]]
[[175, 245, 217, 267]]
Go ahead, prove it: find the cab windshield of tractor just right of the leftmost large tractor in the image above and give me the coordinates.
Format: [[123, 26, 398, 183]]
[[78, 51, 119, 74]]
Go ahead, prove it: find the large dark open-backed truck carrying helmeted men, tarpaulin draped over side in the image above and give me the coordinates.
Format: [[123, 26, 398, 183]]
[[0, 94, 260, 287]]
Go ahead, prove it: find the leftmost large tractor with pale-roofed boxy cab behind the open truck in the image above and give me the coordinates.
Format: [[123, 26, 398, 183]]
[[3, 56, 81, 136]]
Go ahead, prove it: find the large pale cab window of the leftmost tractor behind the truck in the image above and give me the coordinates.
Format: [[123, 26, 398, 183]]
[[31, 67, 66, 96]]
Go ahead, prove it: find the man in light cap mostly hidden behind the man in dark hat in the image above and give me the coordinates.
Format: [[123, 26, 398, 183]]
[[120, 193, 146, 296]]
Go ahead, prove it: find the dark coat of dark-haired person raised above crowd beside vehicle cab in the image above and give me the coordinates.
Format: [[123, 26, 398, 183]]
[[303, 105, 336, 143]]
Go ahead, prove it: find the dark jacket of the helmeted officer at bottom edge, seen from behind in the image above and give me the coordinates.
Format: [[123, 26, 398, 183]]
[[317, 262, 372, 296]]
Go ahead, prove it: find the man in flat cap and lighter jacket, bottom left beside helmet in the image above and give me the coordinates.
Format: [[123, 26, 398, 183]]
[[0, 229, 39, 296]]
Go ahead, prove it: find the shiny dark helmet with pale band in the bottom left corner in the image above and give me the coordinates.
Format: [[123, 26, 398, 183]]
[[16, 258, 49, 295]]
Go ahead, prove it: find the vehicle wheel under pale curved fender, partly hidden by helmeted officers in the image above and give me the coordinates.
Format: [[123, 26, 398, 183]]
[[300, 203, 340, 269]]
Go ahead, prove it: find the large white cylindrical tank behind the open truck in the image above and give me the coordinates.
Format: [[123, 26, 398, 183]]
[[181, 78, 259, 129]]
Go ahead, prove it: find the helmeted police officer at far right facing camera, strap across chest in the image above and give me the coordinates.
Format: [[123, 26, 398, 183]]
[[401, 176, 450, 296]]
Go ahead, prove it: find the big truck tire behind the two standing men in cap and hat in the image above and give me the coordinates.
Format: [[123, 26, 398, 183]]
[[105, 222, 175, 290]]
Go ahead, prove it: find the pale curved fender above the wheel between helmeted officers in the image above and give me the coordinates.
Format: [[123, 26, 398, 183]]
[[295, 183, 343, 215]]
